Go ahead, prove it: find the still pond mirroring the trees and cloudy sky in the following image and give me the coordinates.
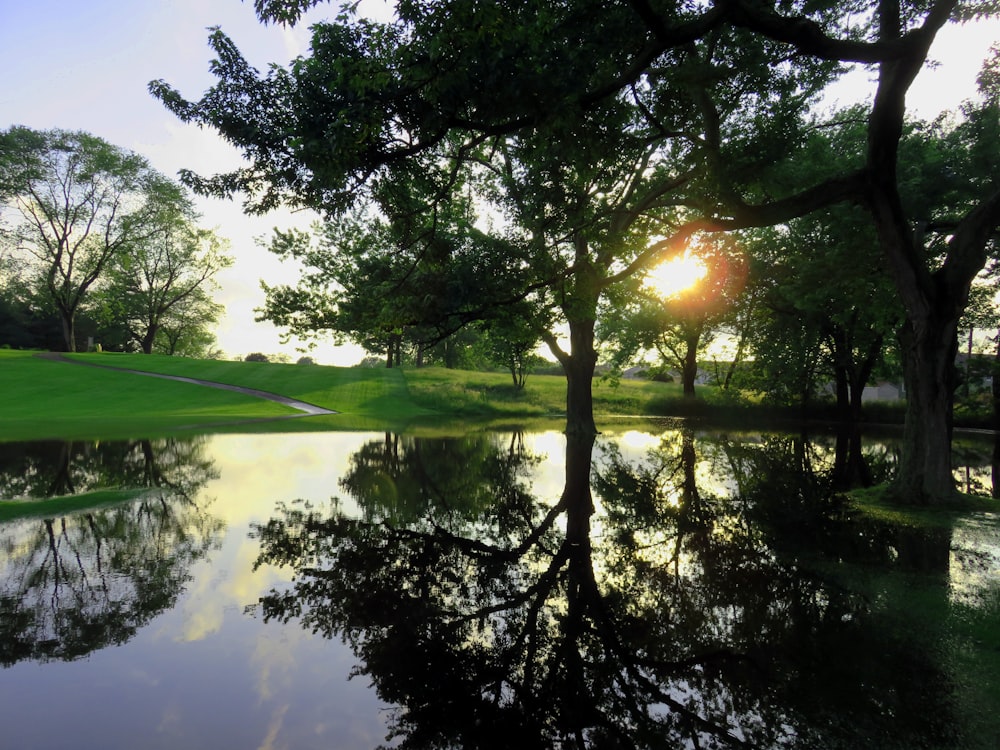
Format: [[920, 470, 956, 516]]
[[0, 422, 1000, 750]]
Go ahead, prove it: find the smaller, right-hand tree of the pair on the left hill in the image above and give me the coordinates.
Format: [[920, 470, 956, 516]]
[[100, 205, 233, 354]]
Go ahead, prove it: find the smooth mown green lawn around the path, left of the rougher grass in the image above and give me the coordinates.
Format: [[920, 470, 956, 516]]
[[0, 351, 436, 440]]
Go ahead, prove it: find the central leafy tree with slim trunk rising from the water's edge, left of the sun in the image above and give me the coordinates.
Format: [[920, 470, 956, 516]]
[[152, 3, 832, 432]]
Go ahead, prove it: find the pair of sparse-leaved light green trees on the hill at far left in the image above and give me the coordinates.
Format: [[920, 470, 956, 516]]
[[0, 126, 231, 353]]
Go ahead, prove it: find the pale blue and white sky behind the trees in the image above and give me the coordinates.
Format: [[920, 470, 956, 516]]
[[0, 0, 1000, 365]]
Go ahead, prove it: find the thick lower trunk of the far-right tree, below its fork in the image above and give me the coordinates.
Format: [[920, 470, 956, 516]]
[[894, 313, 958, 504]]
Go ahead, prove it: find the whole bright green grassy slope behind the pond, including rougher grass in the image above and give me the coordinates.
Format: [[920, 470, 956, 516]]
[[0, 350, 704, 440]]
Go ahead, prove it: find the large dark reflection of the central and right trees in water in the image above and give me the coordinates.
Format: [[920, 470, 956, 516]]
[[254, 430, 988, 748]]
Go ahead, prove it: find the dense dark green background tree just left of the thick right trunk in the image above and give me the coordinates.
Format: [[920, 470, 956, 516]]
[[747, 206, 901, 423]]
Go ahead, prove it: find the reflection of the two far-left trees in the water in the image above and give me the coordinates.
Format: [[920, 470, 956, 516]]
[[0, 440, 222, 666]]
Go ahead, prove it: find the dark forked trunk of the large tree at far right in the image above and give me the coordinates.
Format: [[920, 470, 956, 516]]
[[865, 0, 976, 504]]
